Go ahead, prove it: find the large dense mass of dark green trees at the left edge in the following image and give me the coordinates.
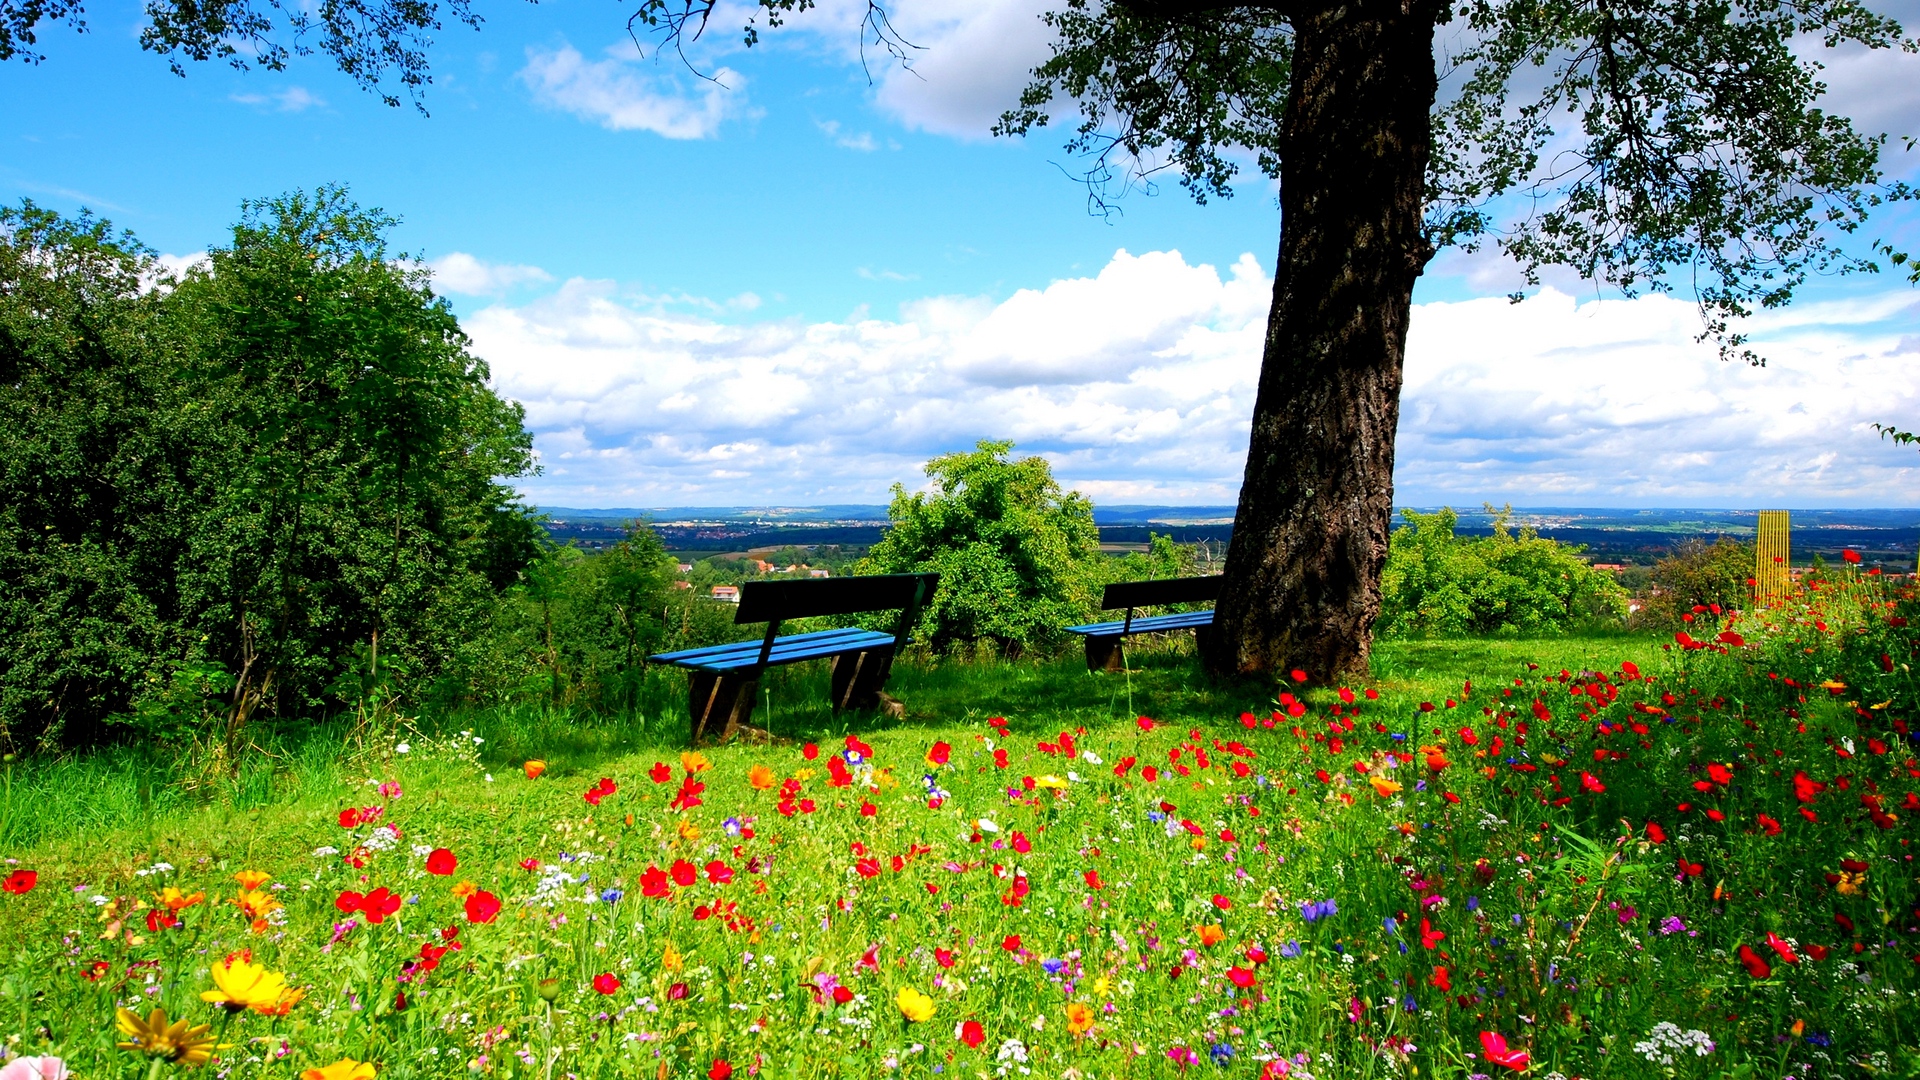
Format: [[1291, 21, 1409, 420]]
[[0, 188, 538, 744]]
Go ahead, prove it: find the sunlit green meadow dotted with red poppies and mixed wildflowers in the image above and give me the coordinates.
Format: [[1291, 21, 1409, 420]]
[[0, 595, 1920, 1080]]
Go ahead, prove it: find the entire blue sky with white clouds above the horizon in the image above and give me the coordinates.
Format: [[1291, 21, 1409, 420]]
[[0, 0, 1920, 507]]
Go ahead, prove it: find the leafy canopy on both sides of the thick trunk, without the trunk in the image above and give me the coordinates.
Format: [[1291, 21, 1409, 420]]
[[998, 0, 1916, 361]]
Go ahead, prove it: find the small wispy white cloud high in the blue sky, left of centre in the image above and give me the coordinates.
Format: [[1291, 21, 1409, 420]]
[[520, 44, 747, 138]]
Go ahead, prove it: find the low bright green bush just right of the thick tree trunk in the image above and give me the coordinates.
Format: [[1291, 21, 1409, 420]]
[[1379, 507, 1626, 636]]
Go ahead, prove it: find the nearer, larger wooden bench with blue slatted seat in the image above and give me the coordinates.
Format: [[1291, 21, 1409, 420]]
[[647, 575, 941, 746]]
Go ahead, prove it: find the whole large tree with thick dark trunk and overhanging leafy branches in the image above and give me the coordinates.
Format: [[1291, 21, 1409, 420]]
[[22, 0, 1916, 675]]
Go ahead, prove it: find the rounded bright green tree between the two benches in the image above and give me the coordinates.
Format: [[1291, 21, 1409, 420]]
[[858, 440, 1102, 653]]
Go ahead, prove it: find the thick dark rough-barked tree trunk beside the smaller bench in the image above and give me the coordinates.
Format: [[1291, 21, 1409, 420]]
[[1208, 0, 1438, 678]]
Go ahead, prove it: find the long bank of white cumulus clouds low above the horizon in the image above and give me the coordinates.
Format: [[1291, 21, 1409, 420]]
[[467, 252, 1920, 505]]
